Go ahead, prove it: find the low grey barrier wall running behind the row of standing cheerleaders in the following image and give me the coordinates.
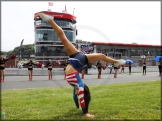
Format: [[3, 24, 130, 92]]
[[5, 66, 159, 76]]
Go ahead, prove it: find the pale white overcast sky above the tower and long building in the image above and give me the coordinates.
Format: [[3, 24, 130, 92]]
[[1, 1, 161, 51]]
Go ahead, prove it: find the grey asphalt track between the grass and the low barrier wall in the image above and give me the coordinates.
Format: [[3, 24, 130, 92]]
[[1, 72, 161, 90]]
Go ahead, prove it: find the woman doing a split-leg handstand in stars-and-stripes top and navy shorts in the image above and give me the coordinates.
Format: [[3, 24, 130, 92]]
[[38, 12, 126, 117]]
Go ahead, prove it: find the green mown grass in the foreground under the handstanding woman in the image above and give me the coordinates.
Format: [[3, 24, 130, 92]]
[[1, 80, 161, 120]]
